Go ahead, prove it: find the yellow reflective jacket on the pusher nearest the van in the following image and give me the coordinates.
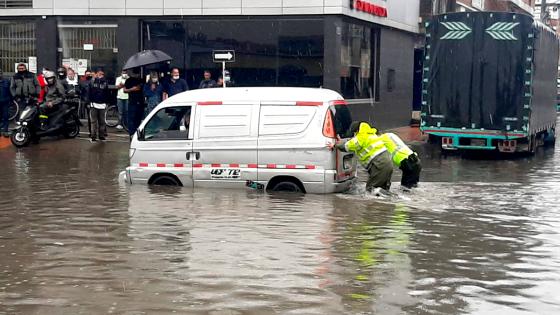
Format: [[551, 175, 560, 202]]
[[344, 123, 387, 168]]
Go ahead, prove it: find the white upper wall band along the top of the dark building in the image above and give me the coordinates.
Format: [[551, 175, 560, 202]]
[[0, 0, 420, 32]]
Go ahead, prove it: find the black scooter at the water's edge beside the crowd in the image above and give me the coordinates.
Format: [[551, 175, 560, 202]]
[[10, 101, 82, 148]]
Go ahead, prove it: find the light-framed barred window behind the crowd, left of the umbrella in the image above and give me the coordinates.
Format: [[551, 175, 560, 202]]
[[58, 24, 119, 77]]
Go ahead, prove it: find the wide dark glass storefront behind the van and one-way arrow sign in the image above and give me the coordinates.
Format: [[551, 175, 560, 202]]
[[143, 19, 324, 88]]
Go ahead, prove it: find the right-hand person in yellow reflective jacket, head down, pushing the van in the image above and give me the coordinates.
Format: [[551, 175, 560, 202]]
[[379, 133, 422, 188]]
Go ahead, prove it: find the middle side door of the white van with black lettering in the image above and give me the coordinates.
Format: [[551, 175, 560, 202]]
[[193, 102, 259, 188]]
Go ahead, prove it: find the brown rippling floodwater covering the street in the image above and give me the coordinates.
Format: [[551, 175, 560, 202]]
[[0, 132, 560, 315]]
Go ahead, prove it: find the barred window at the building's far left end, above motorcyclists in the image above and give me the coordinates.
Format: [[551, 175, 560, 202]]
[[0, 21, 37, 74]]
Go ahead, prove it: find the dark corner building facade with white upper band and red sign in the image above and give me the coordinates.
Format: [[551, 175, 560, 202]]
[[0, 0, 420, 128]]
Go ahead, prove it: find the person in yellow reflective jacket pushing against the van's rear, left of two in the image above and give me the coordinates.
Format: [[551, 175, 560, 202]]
[[329, 122, 393, 191]]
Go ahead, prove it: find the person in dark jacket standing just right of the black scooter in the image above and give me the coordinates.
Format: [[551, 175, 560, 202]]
[[88, 69, 111, 142]]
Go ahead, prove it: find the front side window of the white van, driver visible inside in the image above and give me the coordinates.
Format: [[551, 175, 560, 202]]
[[144, 106, 192, 141]]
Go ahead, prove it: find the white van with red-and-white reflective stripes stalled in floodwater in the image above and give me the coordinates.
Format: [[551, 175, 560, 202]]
[[120, 87, 356, 193]]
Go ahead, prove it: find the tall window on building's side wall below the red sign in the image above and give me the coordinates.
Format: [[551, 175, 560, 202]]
[[340, 23, 379, 101]]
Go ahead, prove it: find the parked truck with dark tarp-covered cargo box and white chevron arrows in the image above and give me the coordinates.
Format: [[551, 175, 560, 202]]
[[421, 12, 559, 153]]
